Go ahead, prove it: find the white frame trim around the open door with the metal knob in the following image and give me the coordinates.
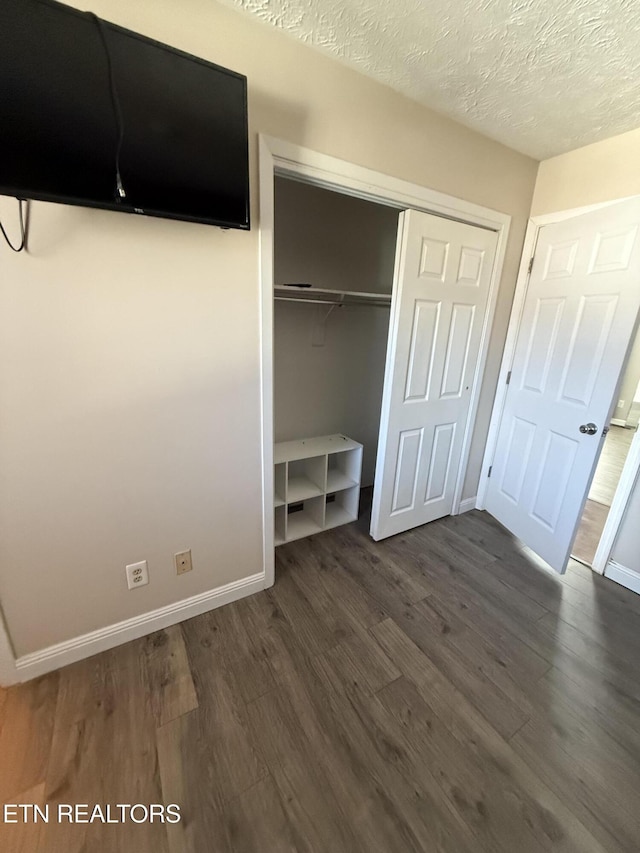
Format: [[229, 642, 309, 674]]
[[477, 196, 640, 574]]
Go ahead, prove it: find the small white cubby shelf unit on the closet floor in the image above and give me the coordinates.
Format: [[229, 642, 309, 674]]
[[274, 434, 362, 545]]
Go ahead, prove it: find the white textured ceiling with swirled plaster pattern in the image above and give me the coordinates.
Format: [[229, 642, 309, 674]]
[[222, 0, 640, 159]]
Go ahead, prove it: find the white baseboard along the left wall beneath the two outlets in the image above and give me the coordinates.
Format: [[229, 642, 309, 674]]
[[16, 572, 265, 681]]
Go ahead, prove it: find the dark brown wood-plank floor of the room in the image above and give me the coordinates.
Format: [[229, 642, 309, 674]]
[[0, 511, 640, 853]]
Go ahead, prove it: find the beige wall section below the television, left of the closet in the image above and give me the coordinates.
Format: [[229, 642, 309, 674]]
[[0, 199, 262, 654]]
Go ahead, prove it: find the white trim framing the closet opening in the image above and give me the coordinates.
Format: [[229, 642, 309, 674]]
[[258, 134, 511, 586]]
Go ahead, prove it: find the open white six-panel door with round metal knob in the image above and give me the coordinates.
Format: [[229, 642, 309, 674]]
[[485, 199, 640, 572]]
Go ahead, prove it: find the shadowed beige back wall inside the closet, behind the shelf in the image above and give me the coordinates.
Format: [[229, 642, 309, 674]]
[[274, 178, 398, 486]]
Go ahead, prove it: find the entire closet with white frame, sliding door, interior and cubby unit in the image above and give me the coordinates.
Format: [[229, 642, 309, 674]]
[[259, 135, 510, 587]]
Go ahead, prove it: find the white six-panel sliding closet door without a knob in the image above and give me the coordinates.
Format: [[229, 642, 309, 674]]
[[371, 210, 497, 539]]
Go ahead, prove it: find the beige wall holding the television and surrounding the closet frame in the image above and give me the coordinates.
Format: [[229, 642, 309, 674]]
[[0, 0, 537, 655]]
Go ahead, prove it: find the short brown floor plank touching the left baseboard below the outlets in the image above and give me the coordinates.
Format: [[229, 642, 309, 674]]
[[144, 625, 198, 726]]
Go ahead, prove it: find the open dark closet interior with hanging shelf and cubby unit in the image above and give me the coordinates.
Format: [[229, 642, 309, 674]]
[[273, 176, 400, 544]]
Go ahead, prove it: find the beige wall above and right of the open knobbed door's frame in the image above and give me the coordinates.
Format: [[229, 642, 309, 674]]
[[532, 128, 640, 572]]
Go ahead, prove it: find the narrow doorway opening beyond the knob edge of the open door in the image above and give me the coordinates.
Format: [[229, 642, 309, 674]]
[[571, 324, 640, 568]]
